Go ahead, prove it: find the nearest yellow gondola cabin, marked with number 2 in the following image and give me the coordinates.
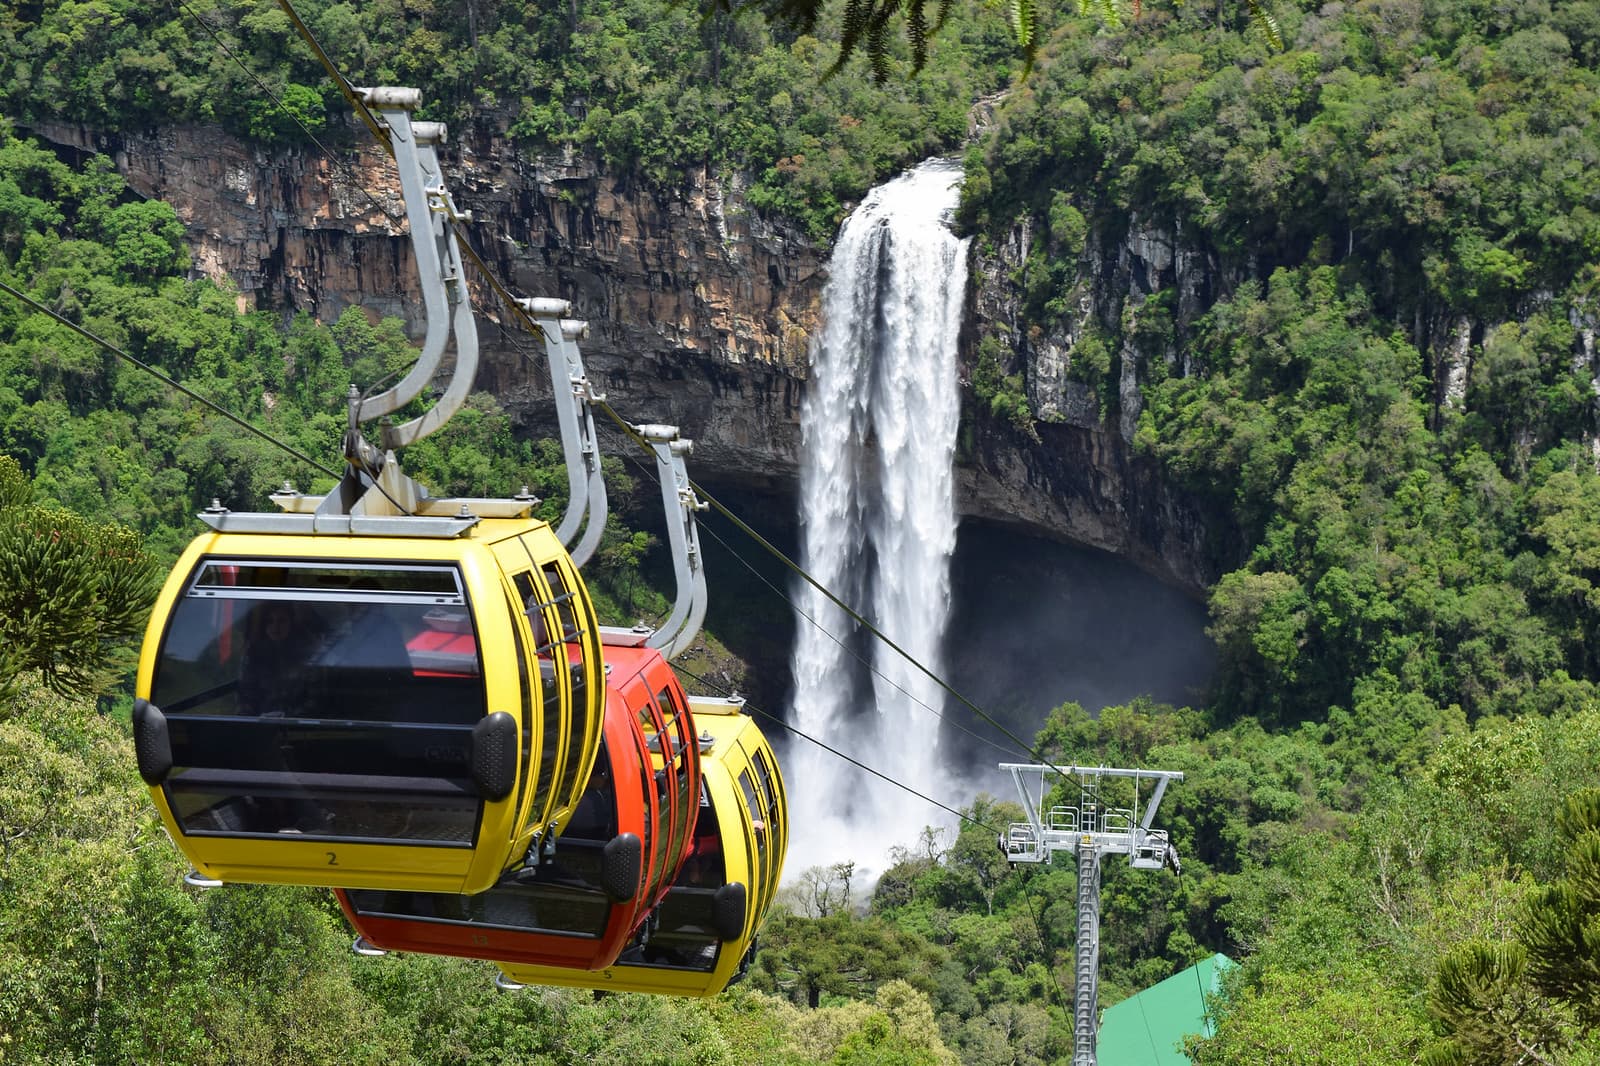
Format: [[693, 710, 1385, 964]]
[[134, 514, 605, 893]]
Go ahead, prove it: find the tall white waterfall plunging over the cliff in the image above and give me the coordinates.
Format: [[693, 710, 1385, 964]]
[[786, 160, 966, 876]]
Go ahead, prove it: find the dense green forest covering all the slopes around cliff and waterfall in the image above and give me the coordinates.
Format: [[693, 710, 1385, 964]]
[[9, 0, 1600, 1064]]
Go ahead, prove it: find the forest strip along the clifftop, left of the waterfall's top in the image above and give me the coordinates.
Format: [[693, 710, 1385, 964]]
[[0, 0, 1016, 240]]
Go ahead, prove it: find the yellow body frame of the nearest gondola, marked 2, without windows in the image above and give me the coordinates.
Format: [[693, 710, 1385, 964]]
[[136, 519, 605, 893]]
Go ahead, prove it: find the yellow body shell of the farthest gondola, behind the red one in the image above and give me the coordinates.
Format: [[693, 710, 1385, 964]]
[[496, 701, 789, 996]]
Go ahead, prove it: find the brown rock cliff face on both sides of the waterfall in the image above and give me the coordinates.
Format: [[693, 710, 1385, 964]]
[[34, 126, 1214, 592]]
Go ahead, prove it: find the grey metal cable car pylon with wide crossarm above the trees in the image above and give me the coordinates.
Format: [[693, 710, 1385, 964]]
[[1000, 762, 1184, 1066]]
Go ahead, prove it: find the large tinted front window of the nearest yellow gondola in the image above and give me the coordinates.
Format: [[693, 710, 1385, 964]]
[[150, 560, 485, 847]]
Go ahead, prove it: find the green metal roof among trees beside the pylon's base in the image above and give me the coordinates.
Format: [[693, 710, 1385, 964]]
[[1096, 954, 1234, 1066]]
